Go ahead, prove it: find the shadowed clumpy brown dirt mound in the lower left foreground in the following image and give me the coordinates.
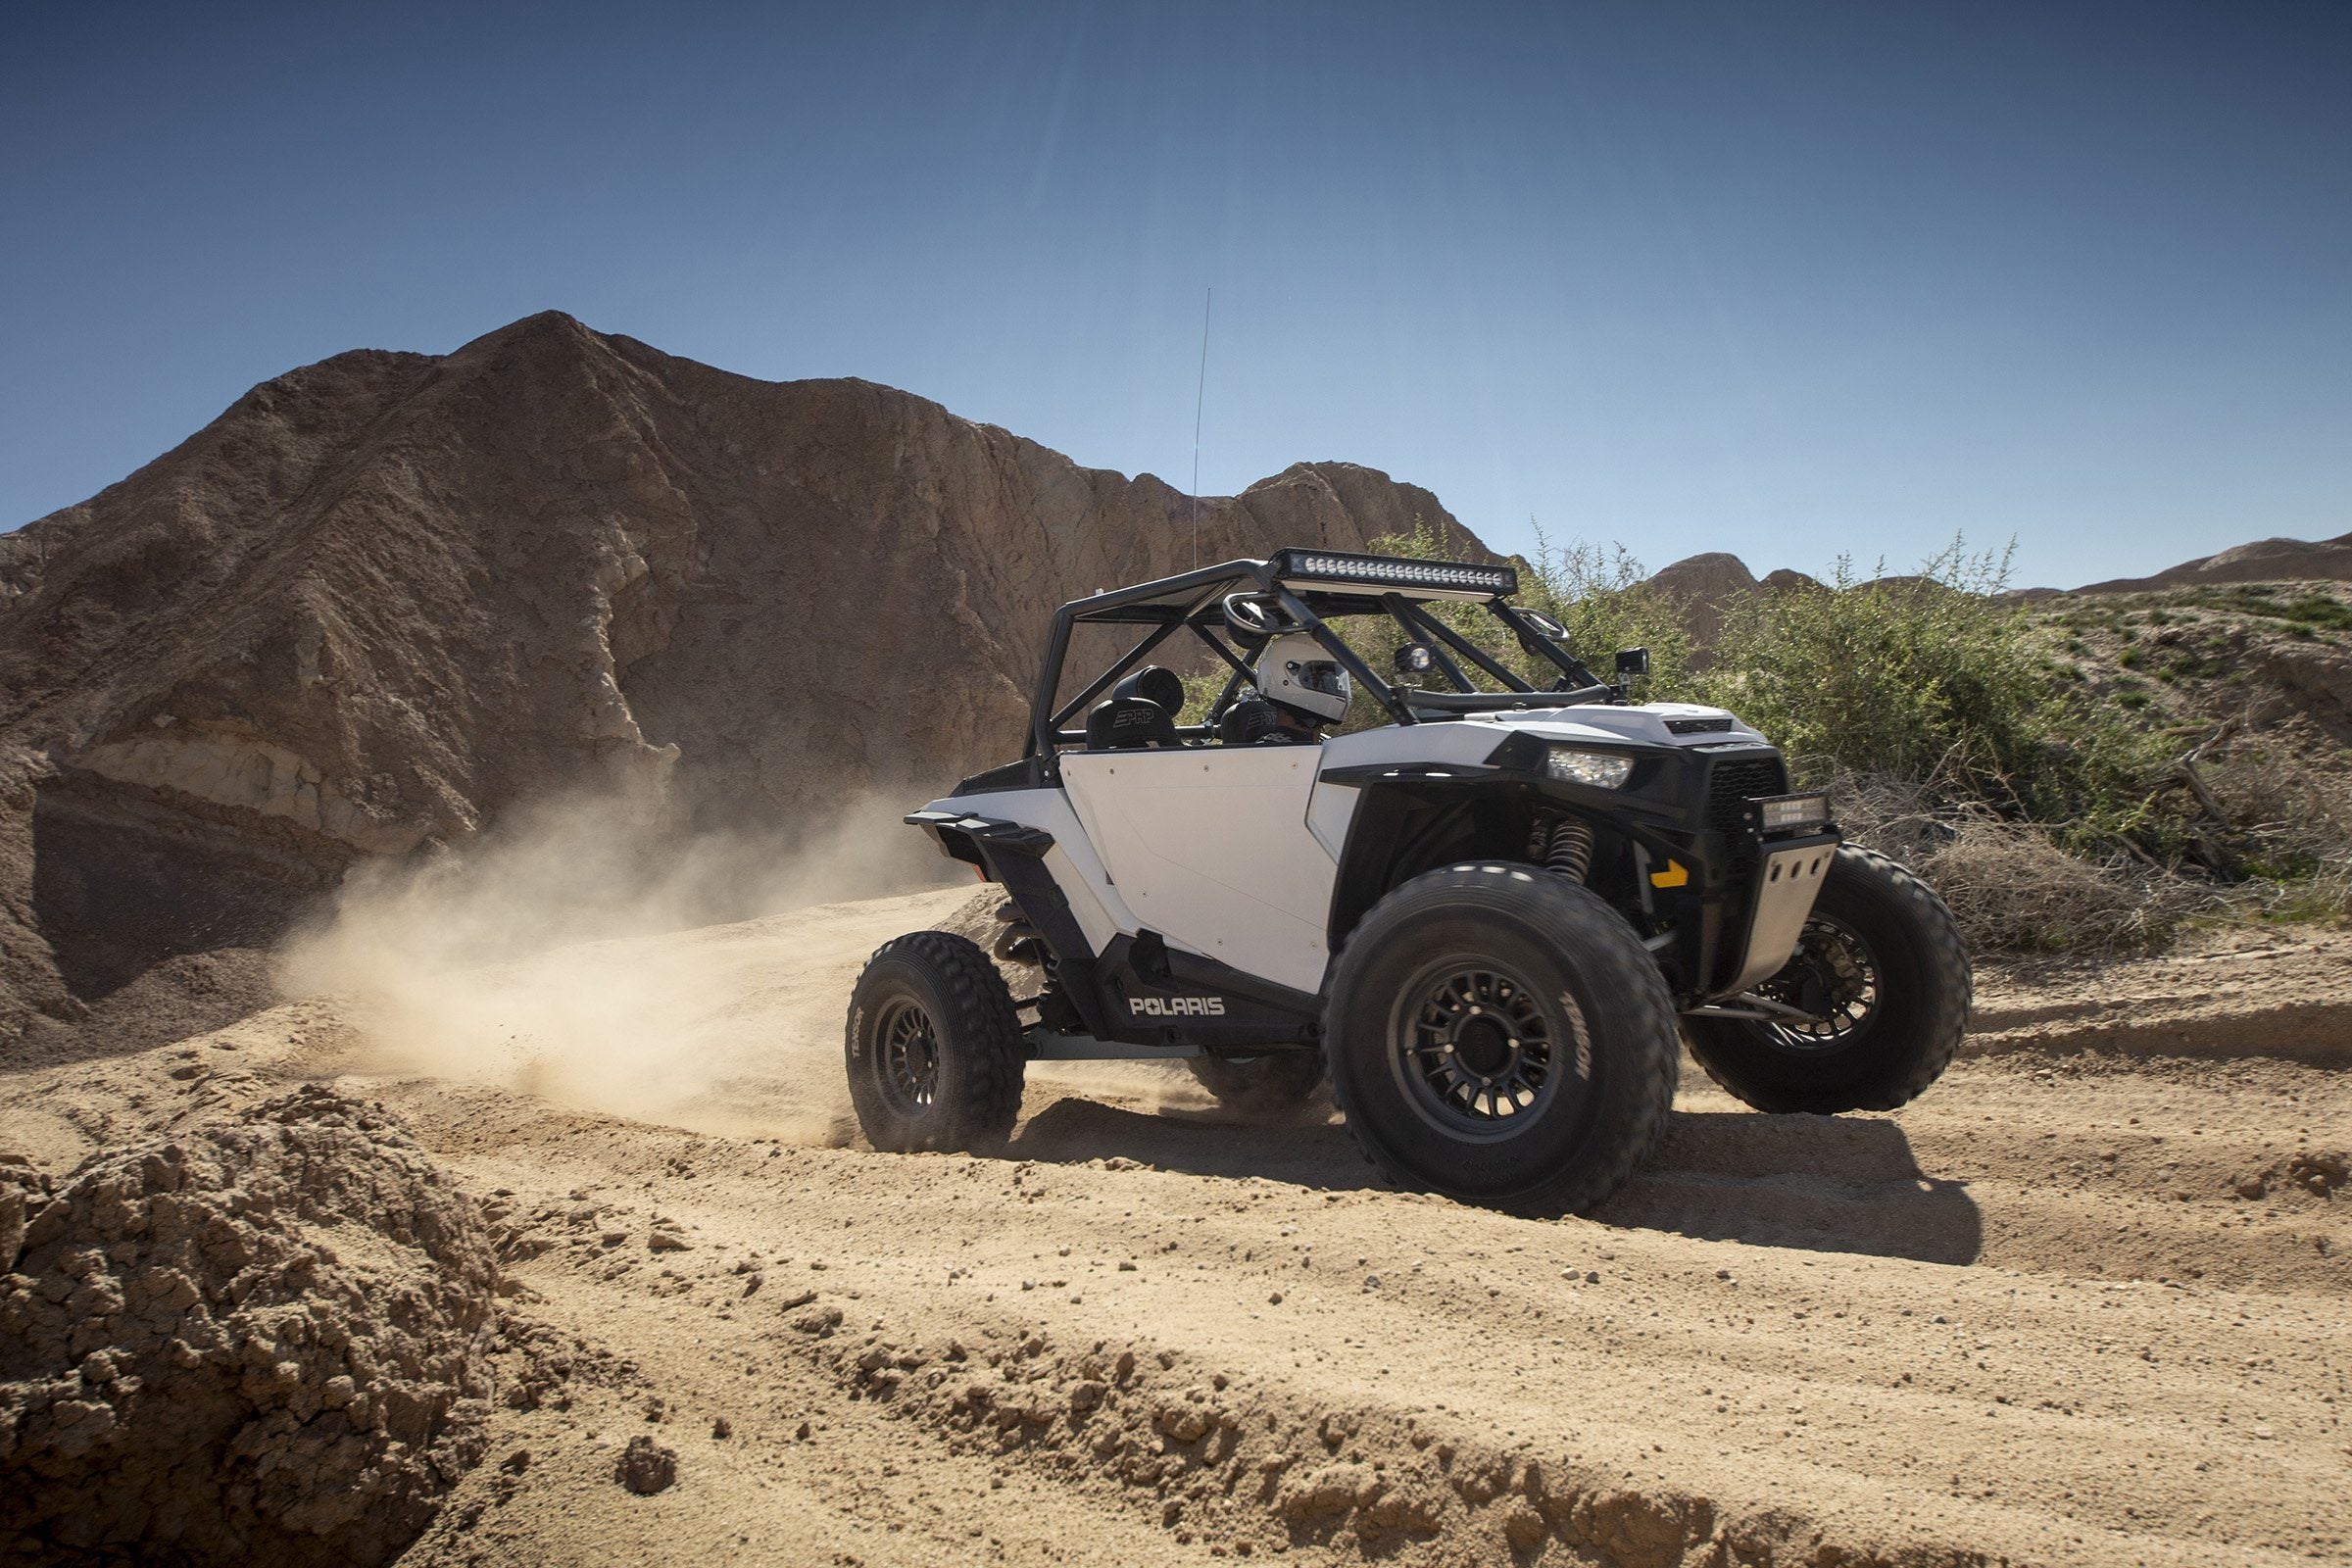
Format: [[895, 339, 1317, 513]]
[[0, 1086, 496, 1563]]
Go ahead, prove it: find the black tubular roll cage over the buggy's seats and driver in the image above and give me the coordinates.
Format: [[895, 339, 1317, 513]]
[[1021, 550, 1618, 768]]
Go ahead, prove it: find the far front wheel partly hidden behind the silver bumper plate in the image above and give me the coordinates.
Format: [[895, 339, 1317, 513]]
[[1684, 844, 1971, 1114]]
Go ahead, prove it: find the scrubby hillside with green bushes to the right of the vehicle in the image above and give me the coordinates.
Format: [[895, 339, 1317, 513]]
[[1376, 526, 2352, 953]]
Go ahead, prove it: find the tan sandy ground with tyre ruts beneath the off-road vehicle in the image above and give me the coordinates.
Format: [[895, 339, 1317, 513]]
[[0, 891, 2352, 1568]]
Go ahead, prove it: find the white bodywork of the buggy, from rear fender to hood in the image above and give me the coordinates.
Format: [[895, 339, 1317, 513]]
[[931, 703, 1762, 992]]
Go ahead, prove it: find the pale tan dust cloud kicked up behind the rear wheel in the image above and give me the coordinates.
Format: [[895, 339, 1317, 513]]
[[280, 795, 971, 1143]]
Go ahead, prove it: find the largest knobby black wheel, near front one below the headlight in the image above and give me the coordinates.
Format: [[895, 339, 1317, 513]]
[[1324, 862, 1682, 1215]]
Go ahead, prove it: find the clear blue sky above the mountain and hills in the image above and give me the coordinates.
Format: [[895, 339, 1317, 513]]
[[0, 0, 2352, 583]]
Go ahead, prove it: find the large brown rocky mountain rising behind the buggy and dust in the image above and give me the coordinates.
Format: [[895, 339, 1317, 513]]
[[0, 313, 1456, 1039]]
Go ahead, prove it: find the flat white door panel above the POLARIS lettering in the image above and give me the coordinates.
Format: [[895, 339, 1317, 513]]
[[1060, 745, 1339, 992]]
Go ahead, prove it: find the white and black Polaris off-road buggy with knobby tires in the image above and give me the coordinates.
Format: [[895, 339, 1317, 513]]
[[847, 548, 1969, 1215]]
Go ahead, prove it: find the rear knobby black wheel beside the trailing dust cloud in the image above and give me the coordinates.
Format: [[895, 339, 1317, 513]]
[[847, 931, 1028, 1154]]
